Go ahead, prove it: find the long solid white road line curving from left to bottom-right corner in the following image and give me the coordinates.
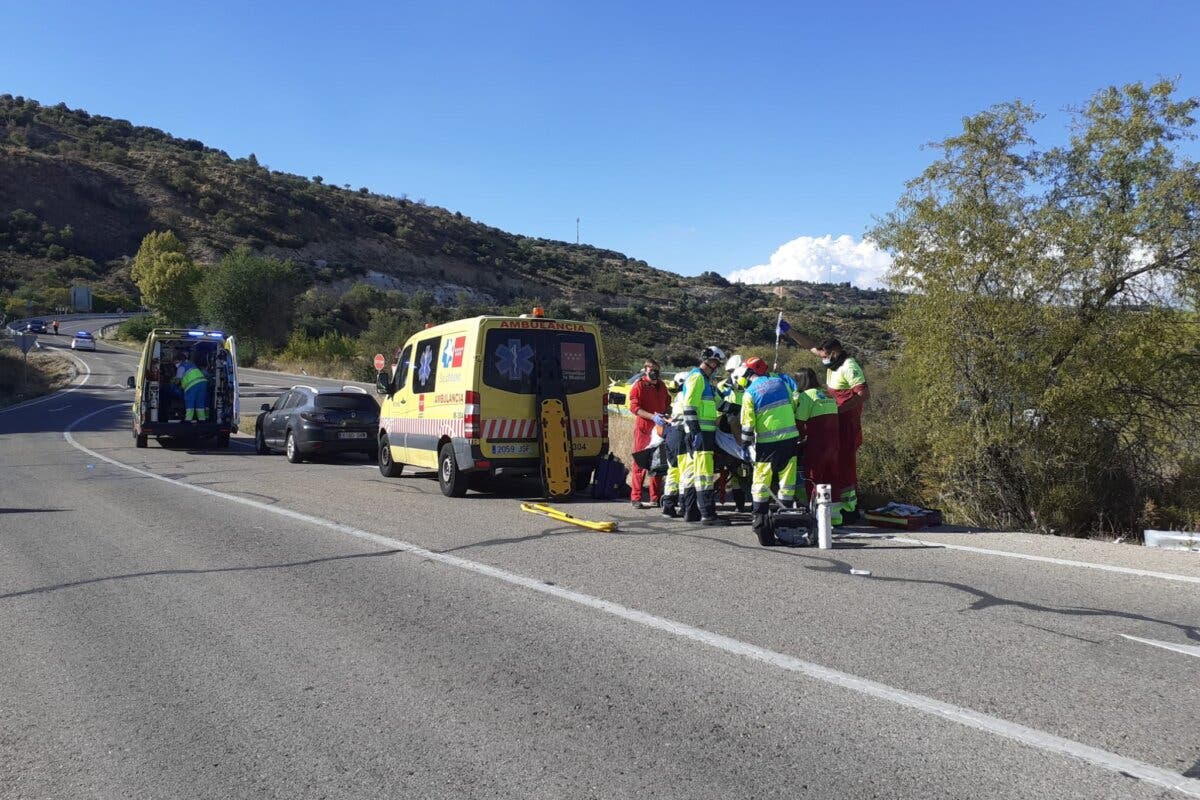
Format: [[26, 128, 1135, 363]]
[[62, 403, 1200, 798]]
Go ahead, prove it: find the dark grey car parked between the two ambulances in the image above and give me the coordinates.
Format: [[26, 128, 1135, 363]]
[[254, 386, 379, 464]]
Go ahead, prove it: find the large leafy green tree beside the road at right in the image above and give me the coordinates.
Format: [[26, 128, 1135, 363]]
[[870, 80, 1200, 534]]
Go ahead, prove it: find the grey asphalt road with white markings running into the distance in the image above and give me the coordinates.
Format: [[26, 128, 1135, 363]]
[[0, 323, 1200, 799]]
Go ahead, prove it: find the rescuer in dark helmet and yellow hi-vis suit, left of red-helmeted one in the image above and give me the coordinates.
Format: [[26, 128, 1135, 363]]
[[683, 347, 730, 525]]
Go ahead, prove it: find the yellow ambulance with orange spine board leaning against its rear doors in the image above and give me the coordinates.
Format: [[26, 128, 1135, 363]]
[[376, 309, 608, 497]]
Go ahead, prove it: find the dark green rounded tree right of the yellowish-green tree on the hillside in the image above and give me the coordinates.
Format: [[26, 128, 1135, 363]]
[[196, 247, 306, 357]]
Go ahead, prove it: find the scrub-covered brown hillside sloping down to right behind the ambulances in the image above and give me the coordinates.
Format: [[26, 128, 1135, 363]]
[[0, 95, 894, 369]]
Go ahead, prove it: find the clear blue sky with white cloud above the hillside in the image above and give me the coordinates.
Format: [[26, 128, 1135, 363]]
[[0, 0, 1200, 284]]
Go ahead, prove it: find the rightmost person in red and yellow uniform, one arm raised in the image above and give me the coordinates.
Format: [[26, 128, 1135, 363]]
[[779, 319, 871, 518]]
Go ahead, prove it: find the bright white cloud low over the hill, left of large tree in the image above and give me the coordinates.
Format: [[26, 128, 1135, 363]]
[[728, 234, 892, 289]]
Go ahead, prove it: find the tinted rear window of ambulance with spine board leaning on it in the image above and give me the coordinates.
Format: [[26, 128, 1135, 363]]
[[484, 327, 600, 395]]
